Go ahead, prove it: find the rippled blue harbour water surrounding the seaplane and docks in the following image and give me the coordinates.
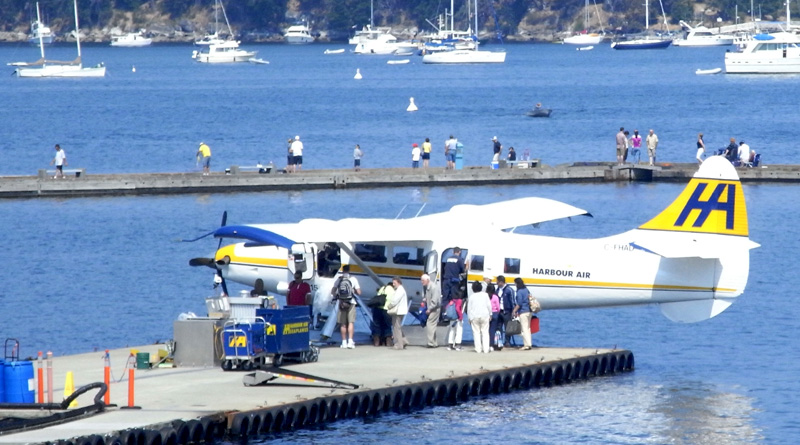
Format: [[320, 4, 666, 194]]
[[0, 45, 800, 444]]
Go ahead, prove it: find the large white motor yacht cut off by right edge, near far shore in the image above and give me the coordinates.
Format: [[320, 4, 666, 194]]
[[725, 32, 800, 74]]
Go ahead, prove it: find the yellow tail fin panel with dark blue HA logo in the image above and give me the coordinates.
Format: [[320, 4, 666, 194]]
[[639, 178, 749, 236]]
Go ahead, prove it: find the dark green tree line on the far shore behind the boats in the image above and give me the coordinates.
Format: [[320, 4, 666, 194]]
[[0, 0, 800, 38]]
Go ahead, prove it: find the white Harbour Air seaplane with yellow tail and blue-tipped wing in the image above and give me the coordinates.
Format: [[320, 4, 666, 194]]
[[189, 156, 759, 323]]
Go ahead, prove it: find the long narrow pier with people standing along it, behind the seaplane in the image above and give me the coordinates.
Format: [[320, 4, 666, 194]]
[[0, 162, 800, 198]]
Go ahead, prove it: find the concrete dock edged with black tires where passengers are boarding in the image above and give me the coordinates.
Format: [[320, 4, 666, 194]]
[[0, 327, 634, 444]]
